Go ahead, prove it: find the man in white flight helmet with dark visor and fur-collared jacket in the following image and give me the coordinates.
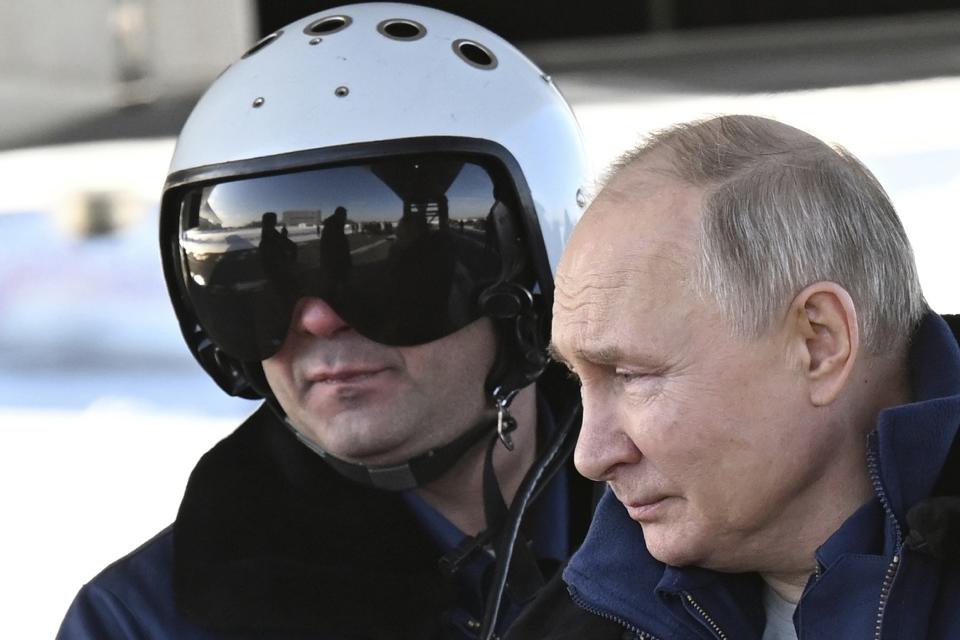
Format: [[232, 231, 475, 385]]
[[60, 3, 592, 639]]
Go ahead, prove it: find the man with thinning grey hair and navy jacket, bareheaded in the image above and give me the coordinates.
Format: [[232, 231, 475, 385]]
[[509, 116, 960, 640]]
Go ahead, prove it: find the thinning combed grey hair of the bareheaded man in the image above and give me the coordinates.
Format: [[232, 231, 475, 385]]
[[617, 115, 927, 354]]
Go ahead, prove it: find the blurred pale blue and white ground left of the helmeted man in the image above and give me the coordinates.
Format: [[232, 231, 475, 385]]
[[0, 212, 253, 639]]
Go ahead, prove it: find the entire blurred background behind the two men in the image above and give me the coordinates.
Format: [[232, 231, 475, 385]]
[[0, 0, 960, 638]]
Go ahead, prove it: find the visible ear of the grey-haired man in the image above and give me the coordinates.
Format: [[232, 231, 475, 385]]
[[790, 282, 860, 407]]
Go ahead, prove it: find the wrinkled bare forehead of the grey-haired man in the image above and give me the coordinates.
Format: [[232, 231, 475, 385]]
[[553, 164, 702, 356]]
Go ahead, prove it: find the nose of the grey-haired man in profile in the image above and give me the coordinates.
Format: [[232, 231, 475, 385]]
[[573, 391, 643, 482]]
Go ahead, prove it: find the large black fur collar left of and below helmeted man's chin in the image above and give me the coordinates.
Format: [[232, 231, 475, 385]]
[[173, 406, 455, 640]]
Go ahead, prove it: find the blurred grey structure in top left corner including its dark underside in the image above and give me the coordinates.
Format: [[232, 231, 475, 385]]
[[0, 0, 257, 149]]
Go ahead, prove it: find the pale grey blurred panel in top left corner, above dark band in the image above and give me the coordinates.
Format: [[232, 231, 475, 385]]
[[0, 0, 256, 98]]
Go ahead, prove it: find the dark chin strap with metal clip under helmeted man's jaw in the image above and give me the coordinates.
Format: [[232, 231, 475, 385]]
[[267, 388, 517, 491]]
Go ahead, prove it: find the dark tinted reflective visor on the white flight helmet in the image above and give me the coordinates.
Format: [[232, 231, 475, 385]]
[[177, 154, 519, 361]]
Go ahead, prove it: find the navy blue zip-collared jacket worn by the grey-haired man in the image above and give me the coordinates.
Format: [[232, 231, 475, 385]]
[[507, 314, 960, 640]]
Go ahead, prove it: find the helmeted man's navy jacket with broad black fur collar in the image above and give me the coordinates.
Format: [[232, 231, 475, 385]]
[[58, 364, 593, 640]]
